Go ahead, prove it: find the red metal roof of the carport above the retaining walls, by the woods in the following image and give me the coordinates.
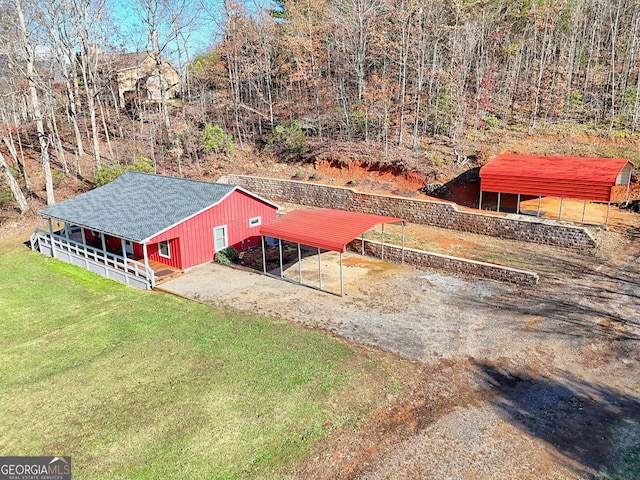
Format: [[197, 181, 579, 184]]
[[480, 154, 633, 201]]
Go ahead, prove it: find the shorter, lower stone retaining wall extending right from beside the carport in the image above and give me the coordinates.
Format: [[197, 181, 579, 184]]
[[347, 238, 538, 287]]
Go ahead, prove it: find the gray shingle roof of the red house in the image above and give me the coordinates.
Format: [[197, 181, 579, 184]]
[[39, 171, 238, 243]]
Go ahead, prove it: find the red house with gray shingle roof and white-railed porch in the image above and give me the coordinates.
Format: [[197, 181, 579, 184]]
[[31, 171, 279, 289]]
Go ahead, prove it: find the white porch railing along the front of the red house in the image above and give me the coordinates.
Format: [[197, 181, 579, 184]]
[[30, 229, 156, 290]]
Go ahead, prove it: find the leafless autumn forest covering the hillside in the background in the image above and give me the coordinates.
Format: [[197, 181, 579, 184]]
[[0, 0, 640, 212]]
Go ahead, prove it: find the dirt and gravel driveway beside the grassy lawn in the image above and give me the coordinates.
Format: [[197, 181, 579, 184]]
[[163, 223, 640, 480]]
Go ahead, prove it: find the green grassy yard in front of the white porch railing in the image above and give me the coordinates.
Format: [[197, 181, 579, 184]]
[[0, 235, 398, 479]]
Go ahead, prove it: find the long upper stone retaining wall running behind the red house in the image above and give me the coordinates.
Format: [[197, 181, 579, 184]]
[[218, 175, 596, 249]]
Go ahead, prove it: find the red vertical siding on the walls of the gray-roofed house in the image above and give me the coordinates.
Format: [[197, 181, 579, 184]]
[[148, 190, 276, 269]]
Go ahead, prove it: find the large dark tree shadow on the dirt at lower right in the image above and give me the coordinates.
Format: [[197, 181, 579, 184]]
[[475, 362, 640, 478]]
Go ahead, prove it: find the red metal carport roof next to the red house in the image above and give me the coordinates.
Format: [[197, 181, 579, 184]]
[[260, 208, 405, 252]]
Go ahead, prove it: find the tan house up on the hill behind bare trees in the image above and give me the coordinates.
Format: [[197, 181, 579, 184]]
[[99, 52, 180, 108]]
